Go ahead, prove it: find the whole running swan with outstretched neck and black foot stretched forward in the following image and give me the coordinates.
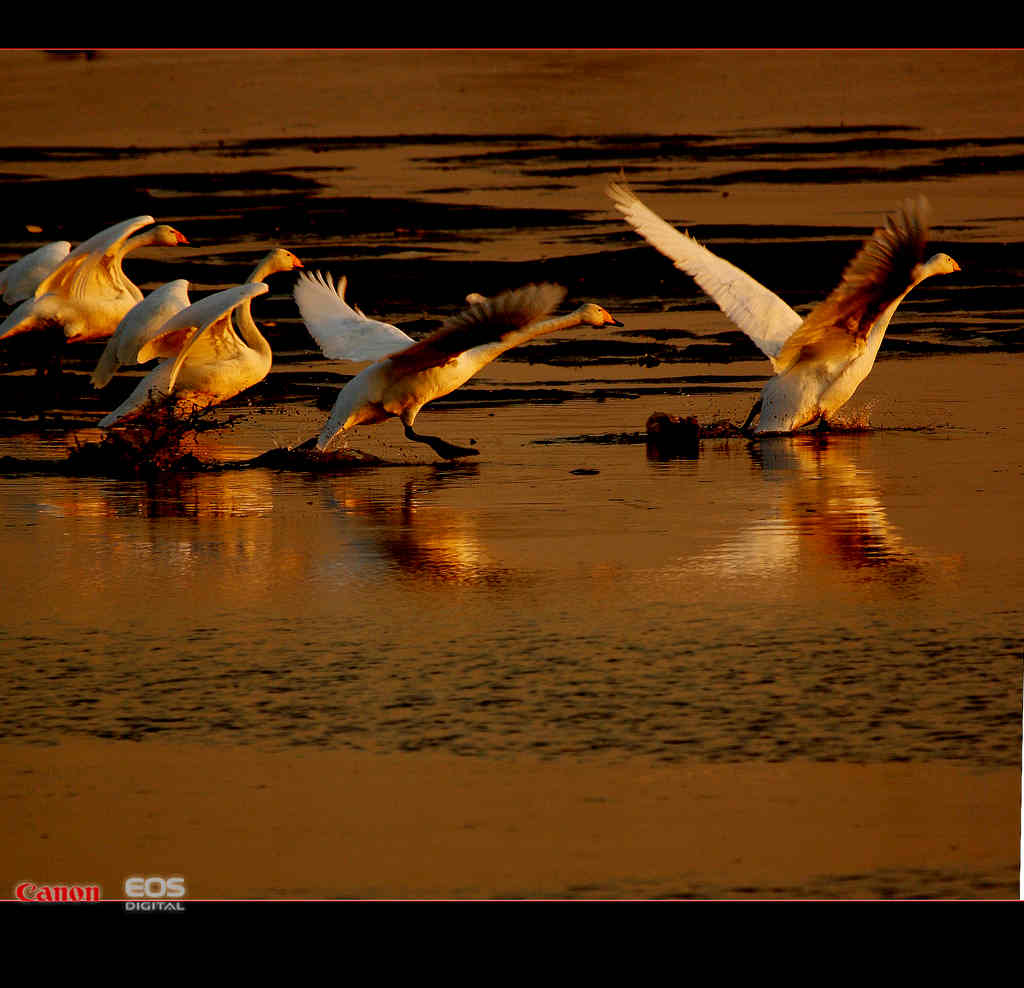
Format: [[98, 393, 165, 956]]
[[295, 274, 623, 460]]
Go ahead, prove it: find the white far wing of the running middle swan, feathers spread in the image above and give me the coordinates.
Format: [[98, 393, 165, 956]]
[[294, 271, 413, 360]]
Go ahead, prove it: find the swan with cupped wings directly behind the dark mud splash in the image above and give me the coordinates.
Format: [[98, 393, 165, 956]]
[[99, 248, 302, 429]]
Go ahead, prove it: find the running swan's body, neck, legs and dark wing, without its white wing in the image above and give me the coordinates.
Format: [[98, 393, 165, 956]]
[[301, 284, 622, 459]]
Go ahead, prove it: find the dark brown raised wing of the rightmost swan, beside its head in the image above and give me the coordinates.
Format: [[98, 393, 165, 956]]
[[776, 196, 929, 373]]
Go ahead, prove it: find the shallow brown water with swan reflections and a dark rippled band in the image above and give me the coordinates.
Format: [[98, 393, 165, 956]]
[[0, 378, 1024, 767]]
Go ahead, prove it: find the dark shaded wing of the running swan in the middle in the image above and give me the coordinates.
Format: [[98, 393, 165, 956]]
[[390, 283, 565, 374]]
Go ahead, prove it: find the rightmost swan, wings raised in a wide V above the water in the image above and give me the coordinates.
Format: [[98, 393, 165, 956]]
[[606, 180, 961, 433]]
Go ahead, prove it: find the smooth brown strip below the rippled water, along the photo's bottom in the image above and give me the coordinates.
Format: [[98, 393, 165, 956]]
[[0, 741, 1020, 899]]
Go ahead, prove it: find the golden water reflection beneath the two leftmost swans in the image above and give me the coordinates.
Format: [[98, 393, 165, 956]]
[[20, 470, 303, 597]]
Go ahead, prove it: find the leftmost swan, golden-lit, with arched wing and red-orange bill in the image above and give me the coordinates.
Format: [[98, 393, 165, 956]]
[[0, 216, 188, 342]]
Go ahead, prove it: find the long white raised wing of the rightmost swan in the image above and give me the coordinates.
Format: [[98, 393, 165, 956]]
[[606, 181, 803, 361]]
